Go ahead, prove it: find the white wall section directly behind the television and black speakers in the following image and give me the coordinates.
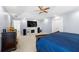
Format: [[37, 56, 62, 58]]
[[20, 19, 37, 34]]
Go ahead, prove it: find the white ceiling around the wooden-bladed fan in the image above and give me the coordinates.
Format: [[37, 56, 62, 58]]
[[3, 6, 79, 19]]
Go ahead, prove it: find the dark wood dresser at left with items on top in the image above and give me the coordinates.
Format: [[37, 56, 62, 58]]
[[1, 32, 17, 52]]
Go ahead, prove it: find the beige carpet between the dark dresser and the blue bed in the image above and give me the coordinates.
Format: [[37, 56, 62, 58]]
[[13, 34, 36, 52]]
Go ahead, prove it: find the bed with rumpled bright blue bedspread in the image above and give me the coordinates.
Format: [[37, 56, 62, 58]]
[[36, 32, 79, 52]]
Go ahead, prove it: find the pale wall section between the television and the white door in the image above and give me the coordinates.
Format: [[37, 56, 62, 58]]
[[38, 18, 52, 33]]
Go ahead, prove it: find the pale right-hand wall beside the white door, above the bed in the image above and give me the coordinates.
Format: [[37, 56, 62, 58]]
[[63, 11, 79, 34]]
